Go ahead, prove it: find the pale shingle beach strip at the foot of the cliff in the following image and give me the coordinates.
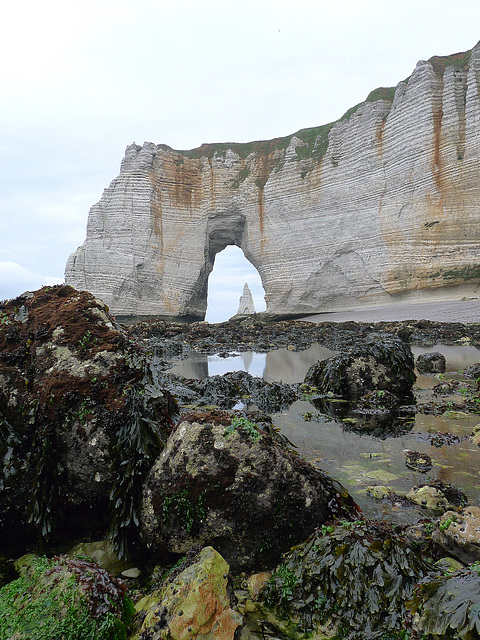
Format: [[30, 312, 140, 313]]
[[305, 300, 480, 324]]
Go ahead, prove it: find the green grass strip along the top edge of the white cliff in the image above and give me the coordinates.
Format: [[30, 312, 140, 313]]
[[158, 42, 472, 159]]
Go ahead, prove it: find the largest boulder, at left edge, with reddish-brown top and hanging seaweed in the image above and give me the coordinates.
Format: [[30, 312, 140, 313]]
[[0, 285, 173, 556]]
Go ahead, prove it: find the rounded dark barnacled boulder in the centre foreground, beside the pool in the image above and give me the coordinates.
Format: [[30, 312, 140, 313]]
[[141, 412, 358, 570]]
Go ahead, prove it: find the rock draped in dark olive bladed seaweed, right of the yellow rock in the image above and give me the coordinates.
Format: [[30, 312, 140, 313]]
[[262, 521, 431, 640]]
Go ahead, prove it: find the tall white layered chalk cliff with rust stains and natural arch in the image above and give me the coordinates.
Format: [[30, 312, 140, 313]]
[[66, 43, 480, 318]]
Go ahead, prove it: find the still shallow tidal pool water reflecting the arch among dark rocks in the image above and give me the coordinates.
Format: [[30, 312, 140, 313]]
[[170, 344, 480, 523]]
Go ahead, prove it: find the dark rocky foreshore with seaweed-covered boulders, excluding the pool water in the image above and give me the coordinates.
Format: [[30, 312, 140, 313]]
[[0, 285, 480, 640]]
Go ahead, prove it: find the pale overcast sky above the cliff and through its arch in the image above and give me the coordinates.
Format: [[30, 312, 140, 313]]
[[0, 0, 480, 321]]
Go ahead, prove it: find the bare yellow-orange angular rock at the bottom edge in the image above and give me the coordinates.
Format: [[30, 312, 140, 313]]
[[130, 547, 242, 640]]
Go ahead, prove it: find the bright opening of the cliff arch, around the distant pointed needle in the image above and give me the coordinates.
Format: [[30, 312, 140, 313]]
[[205, 245, 266, 323]]
